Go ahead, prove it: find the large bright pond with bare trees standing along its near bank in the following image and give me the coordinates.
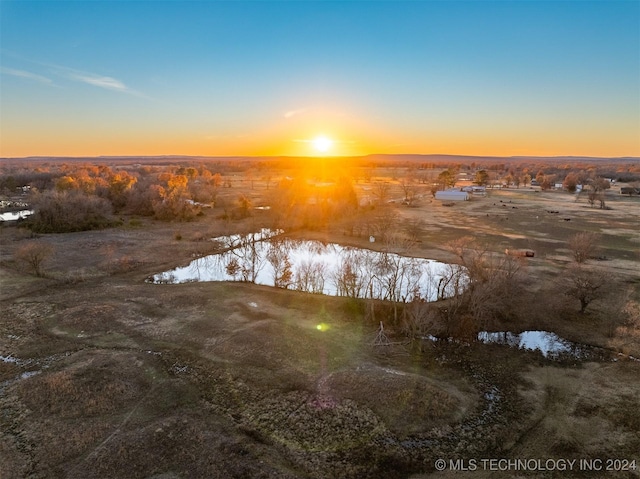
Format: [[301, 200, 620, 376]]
[[147, 230, 466, 301]]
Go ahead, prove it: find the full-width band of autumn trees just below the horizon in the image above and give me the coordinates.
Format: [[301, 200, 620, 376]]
[[0, 156, 640, 231]]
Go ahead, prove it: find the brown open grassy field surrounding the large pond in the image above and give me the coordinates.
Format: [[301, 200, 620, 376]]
[[0, 162, 640, 479]]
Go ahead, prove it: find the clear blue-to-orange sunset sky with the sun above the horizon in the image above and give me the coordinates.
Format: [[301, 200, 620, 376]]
[[0, 0, 640, 157]]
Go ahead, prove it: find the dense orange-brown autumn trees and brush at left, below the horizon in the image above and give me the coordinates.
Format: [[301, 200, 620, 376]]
[[2, 165, 228, 233]]
